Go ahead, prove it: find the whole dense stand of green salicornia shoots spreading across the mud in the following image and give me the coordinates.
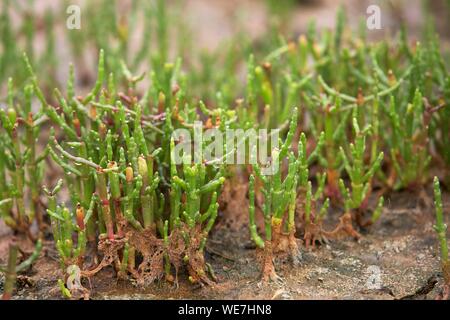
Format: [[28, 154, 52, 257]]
[[0, 0, 450, 298]]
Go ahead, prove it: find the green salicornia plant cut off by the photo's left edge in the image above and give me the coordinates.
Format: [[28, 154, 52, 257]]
[[0, 79, 47, 239]]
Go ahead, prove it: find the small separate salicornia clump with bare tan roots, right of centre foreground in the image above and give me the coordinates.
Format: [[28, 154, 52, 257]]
[[249, 109, 301, 281]]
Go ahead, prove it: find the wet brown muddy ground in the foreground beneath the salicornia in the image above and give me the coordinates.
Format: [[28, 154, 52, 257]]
[[0, 185, 450, 299]]
